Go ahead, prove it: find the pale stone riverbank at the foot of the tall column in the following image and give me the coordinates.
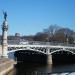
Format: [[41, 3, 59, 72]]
[[0, 58, 15, 75]]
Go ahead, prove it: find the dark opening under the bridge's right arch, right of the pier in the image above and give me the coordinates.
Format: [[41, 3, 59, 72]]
[[51, 49, 75, 64]]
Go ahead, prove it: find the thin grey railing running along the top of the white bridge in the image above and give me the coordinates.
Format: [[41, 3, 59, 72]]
[[9, 41, 75, 47]]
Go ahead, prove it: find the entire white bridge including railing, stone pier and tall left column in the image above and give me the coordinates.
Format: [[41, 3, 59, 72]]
[[0, 12, 75, 64]]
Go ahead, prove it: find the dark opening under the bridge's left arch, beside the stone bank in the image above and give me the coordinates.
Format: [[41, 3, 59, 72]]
[[14, 49, 46, 63]]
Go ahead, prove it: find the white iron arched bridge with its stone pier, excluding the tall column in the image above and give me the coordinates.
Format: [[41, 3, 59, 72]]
[[7, 41, 75, 64]]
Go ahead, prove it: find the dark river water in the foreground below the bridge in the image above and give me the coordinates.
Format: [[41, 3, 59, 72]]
[[8, 63, 75, 75]]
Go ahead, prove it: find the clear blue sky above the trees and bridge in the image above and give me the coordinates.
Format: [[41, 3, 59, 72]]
[[0, 0, 75, 35]]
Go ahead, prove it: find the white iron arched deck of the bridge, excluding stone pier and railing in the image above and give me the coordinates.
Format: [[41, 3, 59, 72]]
[[8, 44, 75, 54]]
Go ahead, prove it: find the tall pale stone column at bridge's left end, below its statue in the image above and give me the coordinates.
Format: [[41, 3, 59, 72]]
[[2, 20, 8, 57]]
